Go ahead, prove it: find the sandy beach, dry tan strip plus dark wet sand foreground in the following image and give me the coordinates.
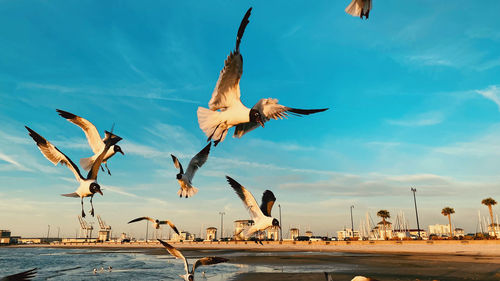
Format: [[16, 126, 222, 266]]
[[7, 240, 500, 281]]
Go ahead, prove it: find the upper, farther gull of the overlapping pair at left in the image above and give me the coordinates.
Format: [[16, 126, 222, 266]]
[[56, 109, 125, 175]]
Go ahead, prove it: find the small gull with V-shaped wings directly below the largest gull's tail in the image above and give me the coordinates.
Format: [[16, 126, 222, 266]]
[[170, 142, 212, 198]]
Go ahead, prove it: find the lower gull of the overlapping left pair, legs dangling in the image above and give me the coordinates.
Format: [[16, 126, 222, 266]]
[[25, 126, 121, 217]]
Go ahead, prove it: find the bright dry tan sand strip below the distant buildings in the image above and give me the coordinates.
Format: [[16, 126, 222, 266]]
[[6, 240, 500, 257]]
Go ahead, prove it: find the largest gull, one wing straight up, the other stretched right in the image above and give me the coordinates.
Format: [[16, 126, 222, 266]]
[[197, 8, 328, 146]]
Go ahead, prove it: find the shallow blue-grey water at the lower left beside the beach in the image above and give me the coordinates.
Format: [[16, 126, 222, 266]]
[[0, 248, 238, 281]]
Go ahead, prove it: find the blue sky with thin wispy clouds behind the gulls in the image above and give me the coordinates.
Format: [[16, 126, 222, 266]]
[[0, 0, 500, 236]]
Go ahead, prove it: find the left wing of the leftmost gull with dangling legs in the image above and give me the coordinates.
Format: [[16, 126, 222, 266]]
[[25, 126, 85, 182]]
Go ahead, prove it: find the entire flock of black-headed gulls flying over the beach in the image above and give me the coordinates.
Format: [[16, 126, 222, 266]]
[[9, 0, 375, 281]]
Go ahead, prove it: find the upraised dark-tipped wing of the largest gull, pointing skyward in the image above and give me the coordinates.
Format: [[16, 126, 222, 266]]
[[208, 8, 252, 110]]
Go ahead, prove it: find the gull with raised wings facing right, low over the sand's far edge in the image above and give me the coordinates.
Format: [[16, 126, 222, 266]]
[[226, 176, 280, 239]]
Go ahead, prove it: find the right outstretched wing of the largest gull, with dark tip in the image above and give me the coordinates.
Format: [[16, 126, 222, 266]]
[[234, 98, 328, 138]]
